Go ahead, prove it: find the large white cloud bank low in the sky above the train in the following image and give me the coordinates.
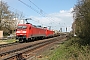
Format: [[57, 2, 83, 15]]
[[31, 8, 73, 31]]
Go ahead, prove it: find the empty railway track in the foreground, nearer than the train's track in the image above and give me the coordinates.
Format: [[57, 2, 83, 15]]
[[0, 37, 66, 60]]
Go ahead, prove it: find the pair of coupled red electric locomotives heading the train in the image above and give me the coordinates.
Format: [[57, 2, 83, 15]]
[[16, 23, 54, 42]]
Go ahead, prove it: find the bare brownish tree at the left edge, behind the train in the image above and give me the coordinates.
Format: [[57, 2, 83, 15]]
[[0, 1, 24, 33]]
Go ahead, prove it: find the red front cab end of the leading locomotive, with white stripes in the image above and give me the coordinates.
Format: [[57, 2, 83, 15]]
[[16, 24, 32, 41]]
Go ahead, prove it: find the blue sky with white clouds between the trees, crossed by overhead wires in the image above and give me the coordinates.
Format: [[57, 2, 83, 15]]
[[2, 0, 77, 32]]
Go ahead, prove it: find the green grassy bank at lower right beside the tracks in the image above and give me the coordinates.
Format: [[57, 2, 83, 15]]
[[48, 37, 90, 60]]
